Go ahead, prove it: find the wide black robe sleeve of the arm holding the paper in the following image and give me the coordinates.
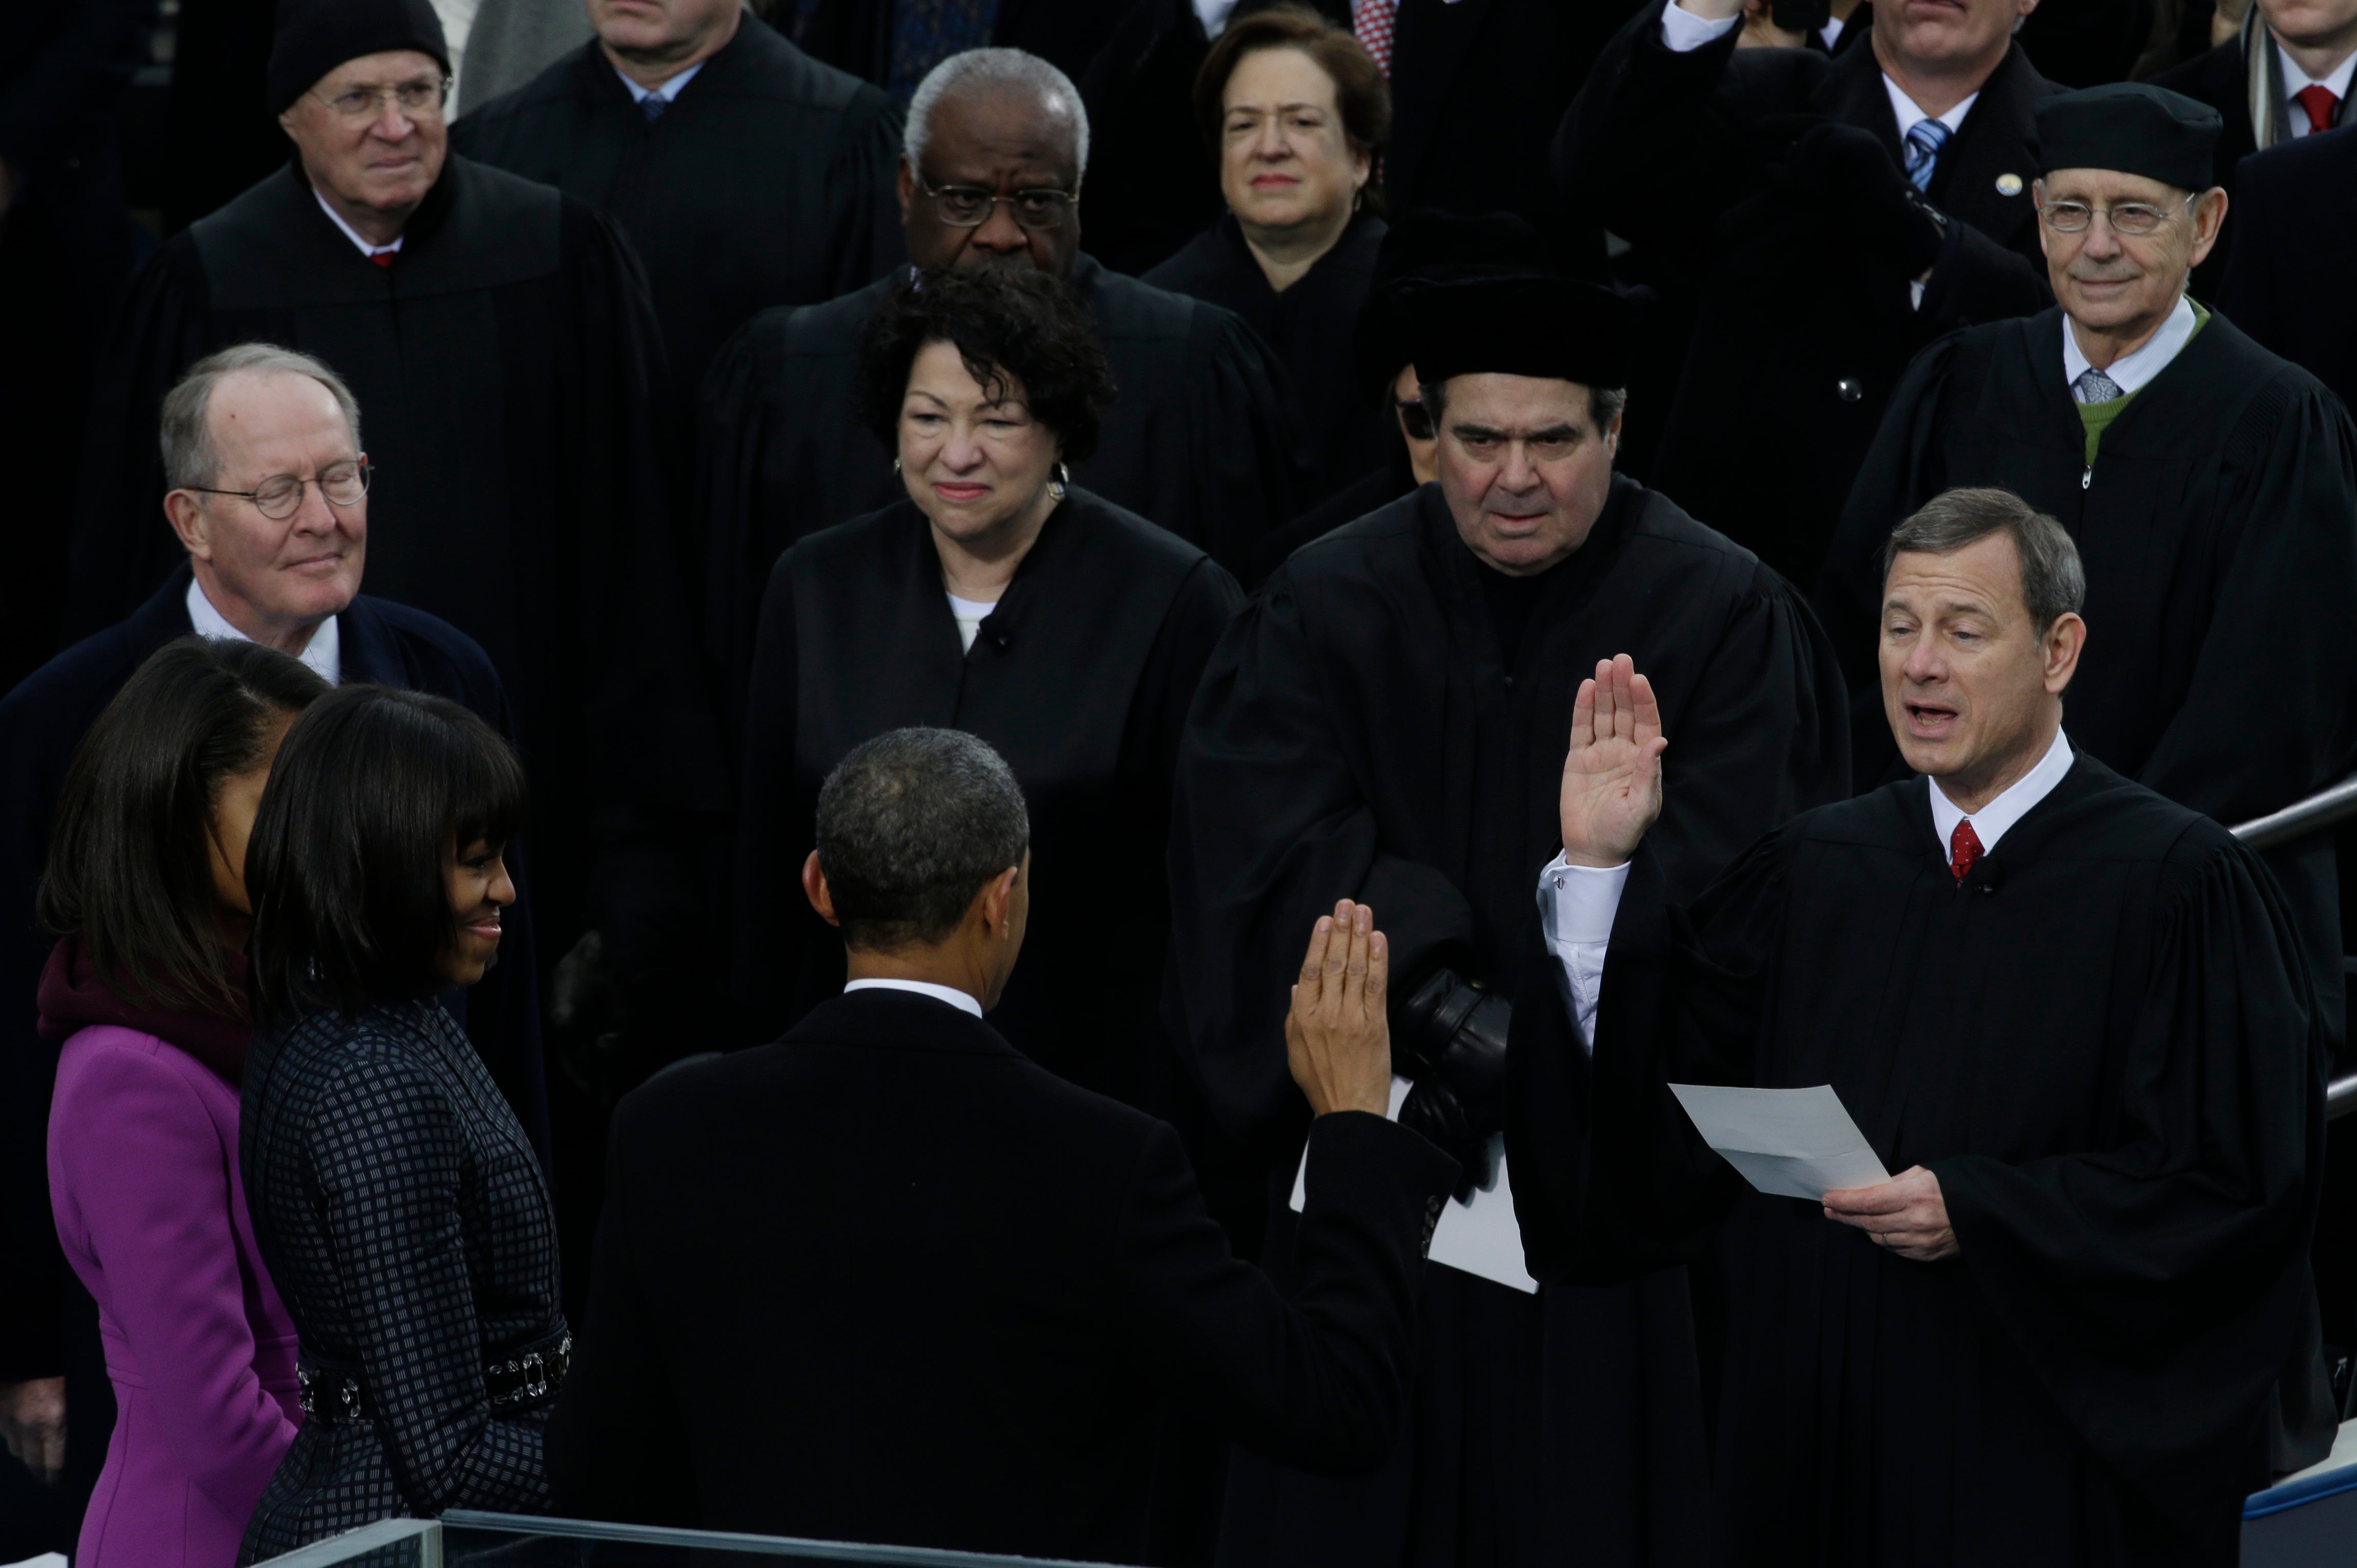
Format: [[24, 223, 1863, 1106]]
[[1933, 828, 2329, 1504]]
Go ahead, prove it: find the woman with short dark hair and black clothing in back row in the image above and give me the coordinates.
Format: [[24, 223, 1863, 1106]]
[[1146, 5, 1391, 493]]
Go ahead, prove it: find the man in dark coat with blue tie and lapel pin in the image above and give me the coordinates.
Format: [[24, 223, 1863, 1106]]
[[1556, 0, 2058, 585]]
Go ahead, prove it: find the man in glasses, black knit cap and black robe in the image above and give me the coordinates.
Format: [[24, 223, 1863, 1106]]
[[66, 0, 726, 1146]]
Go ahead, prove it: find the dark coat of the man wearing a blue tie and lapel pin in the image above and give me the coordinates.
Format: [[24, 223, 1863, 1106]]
[[1556, 7, 2058, 585]]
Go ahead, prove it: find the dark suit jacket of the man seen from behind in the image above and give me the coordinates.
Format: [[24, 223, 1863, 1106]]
[[549, 990, 1457, 1561]]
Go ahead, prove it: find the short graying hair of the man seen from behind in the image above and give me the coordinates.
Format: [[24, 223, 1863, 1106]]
[[818, 728, 1030, 953]]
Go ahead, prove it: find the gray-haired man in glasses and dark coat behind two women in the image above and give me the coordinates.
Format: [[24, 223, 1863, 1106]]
[[0, 344, 547, 1516]]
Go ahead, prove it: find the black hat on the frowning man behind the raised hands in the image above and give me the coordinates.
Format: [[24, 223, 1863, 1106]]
[[1400, 276, 1641, 387]]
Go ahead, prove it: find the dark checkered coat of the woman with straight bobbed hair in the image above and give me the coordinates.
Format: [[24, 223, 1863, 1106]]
[[238, 1002, 566, 1563]]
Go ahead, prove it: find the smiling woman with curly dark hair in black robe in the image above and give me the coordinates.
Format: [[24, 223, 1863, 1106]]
[[733, 266, 1242, 1113]]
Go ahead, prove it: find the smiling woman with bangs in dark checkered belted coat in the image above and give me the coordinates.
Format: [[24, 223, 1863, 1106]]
[[238, 686, 570, 1563]]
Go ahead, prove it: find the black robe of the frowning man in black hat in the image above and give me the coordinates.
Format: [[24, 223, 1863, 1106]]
[[1169, 476, 1848, 1568]]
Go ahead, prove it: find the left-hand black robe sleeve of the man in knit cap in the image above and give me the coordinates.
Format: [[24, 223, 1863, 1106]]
[[64, 236, 215, 639]]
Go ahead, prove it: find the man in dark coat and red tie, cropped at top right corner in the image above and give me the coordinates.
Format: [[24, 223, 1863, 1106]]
[[2152, 0, 2357, 294]]
